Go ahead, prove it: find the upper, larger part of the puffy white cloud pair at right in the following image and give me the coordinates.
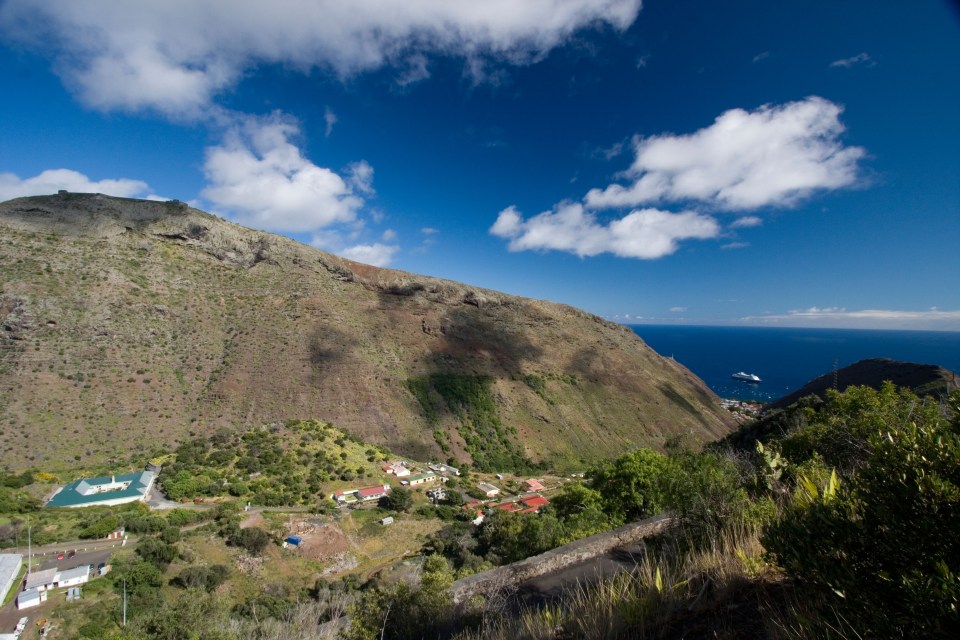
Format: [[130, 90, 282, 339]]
[[585, 96, 865, 210]]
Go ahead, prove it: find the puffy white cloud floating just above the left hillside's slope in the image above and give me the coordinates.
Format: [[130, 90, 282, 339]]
[[202, 115, 373, 232]]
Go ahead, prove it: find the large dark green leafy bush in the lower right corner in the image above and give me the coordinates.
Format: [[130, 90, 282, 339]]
[[763, 389, 960, 638]]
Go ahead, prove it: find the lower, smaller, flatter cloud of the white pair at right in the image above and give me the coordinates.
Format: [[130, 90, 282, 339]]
[[490, 202, 720, 259]]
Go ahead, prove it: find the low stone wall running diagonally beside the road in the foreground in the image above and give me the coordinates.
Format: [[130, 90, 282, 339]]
[[450, 515, 673, 604]]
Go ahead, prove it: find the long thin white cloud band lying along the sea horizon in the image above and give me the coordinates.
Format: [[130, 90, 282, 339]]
[[740, 307, 960, 331]]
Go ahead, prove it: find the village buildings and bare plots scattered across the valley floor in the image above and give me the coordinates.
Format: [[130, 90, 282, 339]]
[[0, 444, 565, 640]]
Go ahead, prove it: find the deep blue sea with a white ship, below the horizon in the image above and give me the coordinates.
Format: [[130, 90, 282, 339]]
[[630, 325, 960, 402]]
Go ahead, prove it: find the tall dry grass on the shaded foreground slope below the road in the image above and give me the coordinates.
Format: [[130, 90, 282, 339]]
[[456, 528, 789, 640]]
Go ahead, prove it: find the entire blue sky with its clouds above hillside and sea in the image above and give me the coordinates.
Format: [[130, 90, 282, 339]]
[[0, 0, 960, 331]]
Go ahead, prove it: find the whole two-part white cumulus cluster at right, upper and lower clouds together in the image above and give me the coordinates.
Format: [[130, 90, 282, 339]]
[[490, 96, 865, 259]]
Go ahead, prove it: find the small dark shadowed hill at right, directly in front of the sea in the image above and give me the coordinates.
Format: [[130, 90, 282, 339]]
[[768, 358, 958, 409]]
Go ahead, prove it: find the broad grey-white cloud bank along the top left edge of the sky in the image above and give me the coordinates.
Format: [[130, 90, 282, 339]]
[[0, 0, 641, 116]]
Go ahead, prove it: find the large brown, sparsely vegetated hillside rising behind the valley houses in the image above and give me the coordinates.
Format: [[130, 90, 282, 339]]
[[0, 193, 732, 469]]
